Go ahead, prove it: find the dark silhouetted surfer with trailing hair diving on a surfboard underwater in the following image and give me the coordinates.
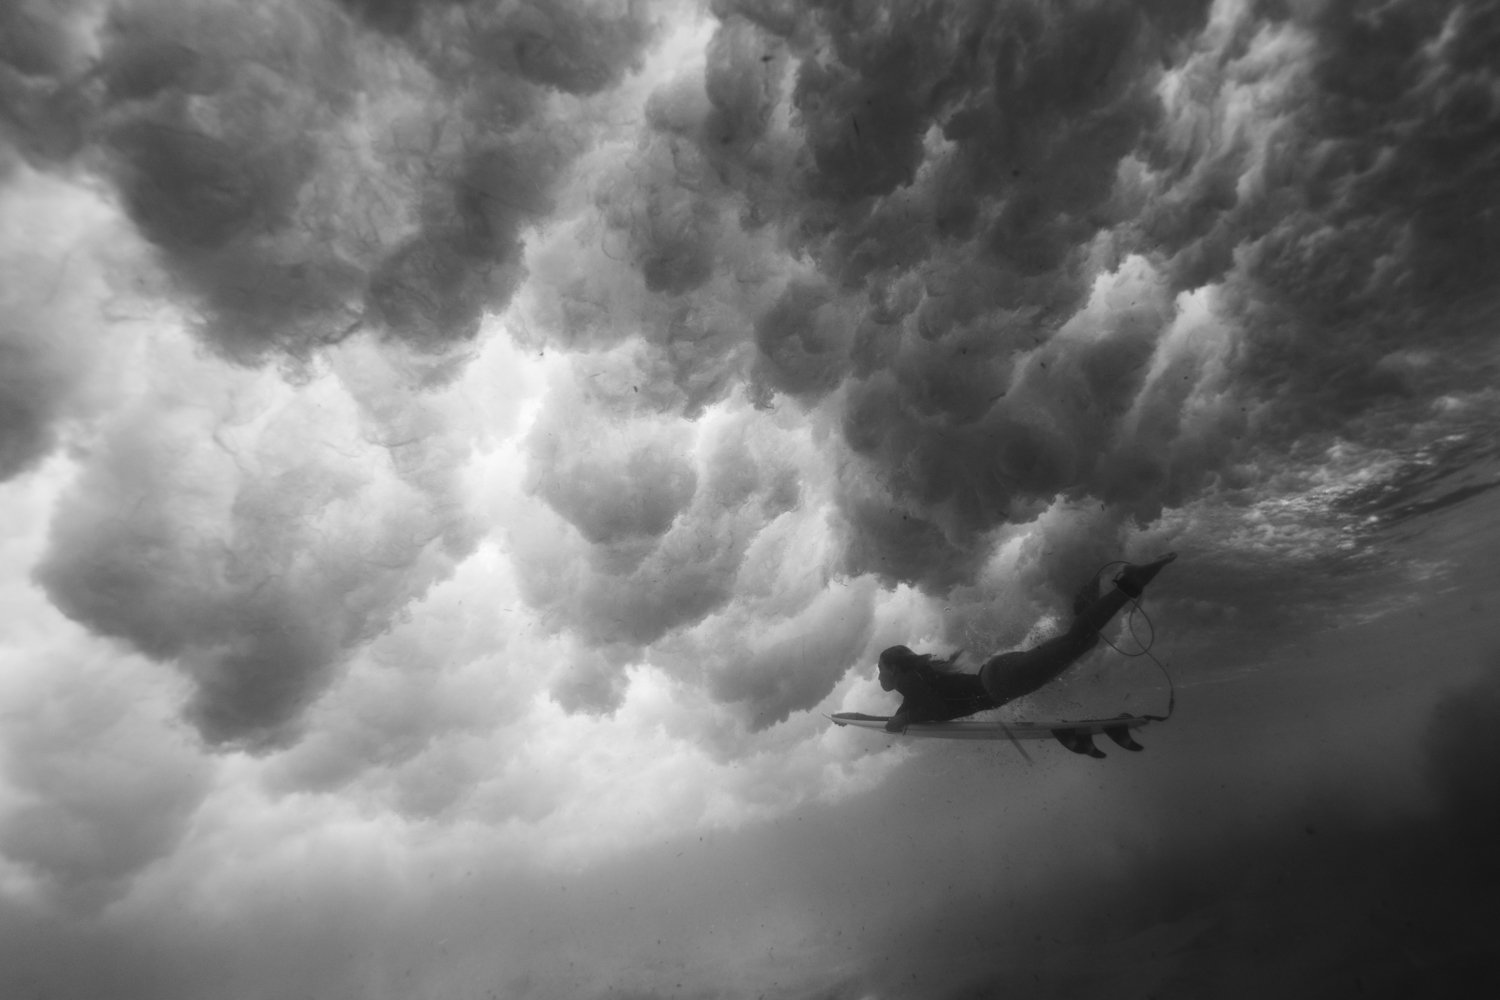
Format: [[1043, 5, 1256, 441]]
[[879, 553, 1178, 733]]
